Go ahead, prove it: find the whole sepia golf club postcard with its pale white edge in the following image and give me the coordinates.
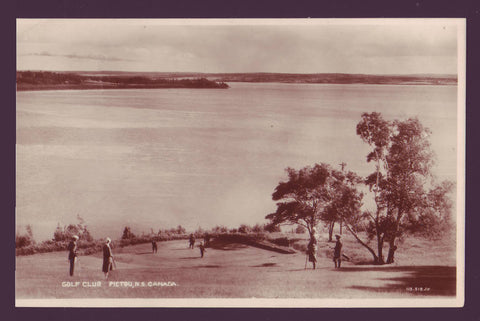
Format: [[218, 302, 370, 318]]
[[15, 18, 466, 308]]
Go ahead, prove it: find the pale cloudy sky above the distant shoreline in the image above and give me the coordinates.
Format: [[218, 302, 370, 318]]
[[17, 19, 459, 74]]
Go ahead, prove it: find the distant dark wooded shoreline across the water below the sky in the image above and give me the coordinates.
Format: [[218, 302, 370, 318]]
[[17, 71, 458, 91]]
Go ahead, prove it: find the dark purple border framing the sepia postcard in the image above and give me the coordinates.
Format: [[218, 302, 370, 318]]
[[4, 0, 480, 321]]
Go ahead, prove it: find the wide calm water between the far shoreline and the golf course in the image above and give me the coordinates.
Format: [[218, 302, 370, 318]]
[[17, 83, 457, 239]]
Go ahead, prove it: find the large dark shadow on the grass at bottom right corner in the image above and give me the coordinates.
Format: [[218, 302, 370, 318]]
[[338, 266, 457, 296]]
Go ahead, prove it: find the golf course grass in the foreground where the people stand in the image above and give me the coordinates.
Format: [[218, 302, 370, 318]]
[[16, 231, 456, 299]]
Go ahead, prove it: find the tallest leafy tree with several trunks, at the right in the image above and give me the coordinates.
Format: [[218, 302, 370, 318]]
[[346, 113, 453, 264]]
